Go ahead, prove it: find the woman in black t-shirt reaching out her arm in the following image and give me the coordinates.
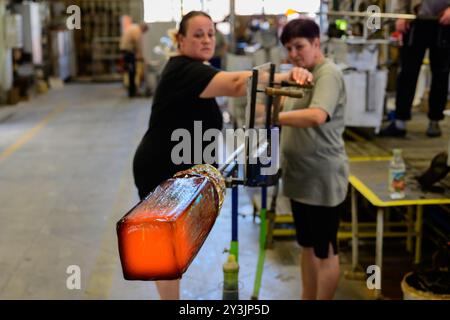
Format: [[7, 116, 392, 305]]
[[133, 11, 309, 299]]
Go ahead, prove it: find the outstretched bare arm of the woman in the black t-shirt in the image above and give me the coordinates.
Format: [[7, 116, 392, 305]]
[[200, 71, 252, 98]]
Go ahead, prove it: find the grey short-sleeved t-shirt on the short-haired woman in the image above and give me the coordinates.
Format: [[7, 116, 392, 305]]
[[281, 60, 349, 207]]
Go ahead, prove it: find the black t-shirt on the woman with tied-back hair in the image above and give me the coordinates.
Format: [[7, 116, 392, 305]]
[[134, 56, 223, 197]]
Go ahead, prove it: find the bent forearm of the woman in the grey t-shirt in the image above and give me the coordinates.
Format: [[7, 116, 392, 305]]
[[278, 107, 328, 128]]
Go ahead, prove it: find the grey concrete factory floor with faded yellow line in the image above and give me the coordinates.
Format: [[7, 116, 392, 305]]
[[0, 84, 448, 299]]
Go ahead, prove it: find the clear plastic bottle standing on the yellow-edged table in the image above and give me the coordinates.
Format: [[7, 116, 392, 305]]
[[389, 149, 406, 200]]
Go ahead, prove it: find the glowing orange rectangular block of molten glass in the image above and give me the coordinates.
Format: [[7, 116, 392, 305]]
[[117, 165, 225, 280]]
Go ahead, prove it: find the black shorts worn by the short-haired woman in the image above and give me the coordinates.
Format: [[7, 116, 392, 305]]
[[291, 200, 344, 259]]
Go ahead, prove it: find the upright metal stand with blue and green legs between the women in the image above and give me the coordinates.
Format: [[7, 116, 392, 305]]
[[219, 63, 311, 299]]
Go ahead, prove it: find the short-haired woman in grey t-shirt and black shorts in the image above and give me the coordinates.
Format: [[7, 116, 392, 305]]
[[279, 18, 349, 300]]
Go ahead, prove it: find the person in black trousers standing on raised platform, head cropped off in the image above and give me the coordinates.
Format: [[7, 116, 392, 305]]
[[380, 0, 450, 137]]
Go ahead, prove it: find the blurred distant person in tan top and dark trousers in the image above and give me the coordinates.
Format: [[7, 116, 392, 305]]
[[120, 23, 148, 98]]
